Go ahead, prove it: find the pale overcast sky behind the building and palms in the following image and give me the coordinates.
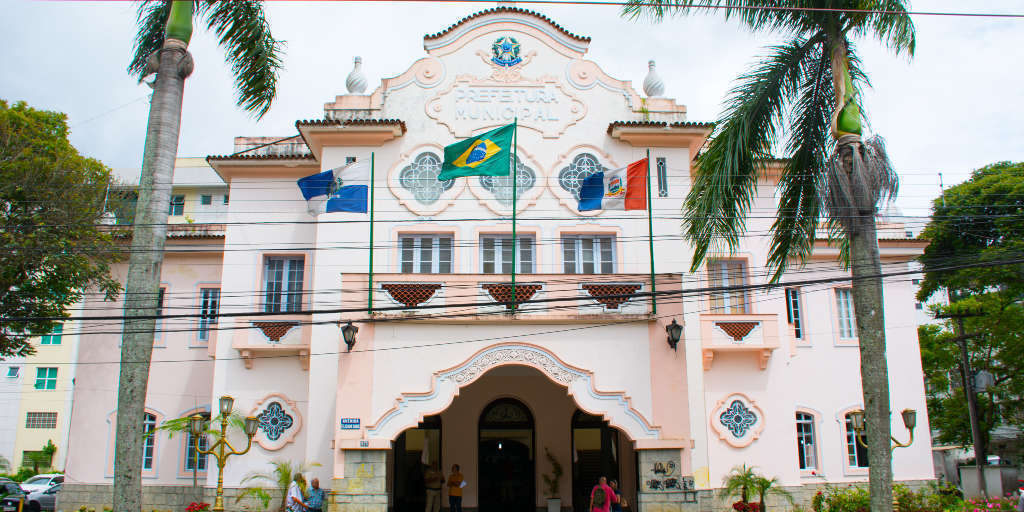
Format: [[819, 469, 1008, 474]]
[[0, 0, 1024, 215]]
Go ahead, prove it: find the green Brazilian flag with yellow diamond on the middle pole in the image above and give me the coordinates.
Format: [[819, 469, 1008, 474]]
[[437, 123, 515, 180]]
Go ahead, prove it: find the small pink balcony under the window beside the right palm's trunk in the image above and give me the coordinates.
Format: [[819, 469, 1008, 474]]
[[700, 314, 778, 372]]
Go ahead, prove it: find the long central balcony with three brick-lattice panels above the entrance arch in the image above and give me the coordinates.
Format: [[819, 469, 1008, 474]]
[[342, 273, 680, 323]]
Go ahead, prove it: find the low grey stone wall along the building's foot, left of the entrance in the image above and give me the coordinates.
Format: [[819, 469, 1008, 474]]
[[56, 482, 282, 512]]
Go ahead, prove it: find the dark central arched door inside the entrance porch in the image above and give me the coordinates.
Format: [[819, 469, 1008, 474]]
[[477, 398, 536, 512]]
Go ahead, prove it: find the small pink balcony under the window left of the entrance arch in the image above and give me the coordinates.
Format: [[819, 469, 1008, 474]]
[[231, 314, 312, 370]]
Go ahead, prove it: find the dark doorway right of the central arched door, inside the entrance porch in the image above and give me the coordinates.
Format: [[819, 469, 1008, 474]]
[[572, 410, 624, 512]]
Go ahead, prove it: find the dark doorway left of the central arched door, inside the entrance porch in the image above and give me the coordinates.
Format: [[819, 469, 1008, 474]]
[[393, 416, 442, 512]]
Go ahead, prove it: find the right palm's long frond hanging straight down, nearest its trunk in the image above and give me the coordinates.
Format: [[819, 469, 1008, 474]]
[[768, 35, 835, 283]]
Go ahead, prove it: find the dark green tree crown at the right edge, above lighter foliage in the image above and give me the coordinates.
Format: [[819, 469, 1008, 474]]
[[918, 162, 1024, 301]]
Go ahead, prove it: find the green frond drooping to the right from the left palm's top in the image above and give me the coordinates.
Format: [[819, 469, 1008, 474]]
[[200, 0, 284, 119]]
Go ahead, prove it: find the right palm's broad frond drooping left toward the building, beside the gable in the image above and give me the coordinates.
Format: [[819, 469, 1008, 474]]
[[684, 37, 820, 271]]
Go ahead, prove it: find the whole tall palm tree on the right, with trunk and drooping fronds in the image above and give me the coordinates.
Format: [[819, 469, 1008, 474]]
[[624, 0, 915, 512]]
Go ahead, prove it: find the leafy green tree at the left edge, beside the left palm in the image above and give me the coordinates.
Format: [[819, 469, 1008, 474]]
[[0, 100, 121, 357]]
